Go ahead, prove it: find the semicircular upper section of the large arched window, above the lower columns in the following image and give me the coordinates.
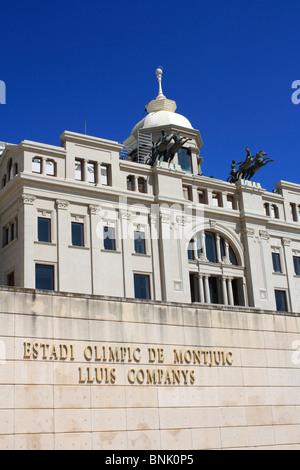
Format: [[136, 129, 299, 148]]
[[188, 231, 239, 266]]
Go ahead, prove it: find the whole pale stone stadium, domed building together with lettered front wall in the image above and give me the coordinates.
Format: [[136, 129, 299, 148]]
[[0, 73, 300, 450]]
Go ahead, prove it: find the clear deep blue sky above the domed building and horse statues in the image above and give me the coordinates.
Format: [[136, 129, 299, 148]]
[[0, 0, 300, 191]]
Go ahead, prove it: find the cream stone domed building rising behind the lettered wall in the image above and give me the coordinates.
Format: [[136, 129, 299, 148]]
[[0, 70, 300, 312]]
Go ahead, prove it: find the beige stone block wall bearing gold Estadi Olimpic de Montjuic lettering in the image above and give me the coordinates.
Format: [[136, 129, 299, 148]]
[[0, 288, 300, 450]]
